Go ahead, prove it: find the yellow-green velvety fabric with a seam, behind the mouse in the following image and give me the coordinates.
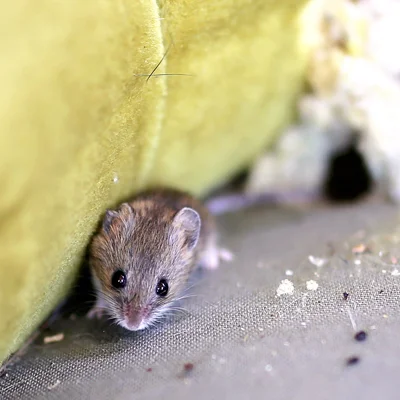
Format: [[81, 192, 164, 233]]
[[0, 0, 307, 362]]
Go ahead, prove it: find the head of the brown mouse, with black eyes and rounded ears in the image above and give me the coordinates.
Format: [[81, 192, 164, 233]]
[[90, 203, 201, 330]]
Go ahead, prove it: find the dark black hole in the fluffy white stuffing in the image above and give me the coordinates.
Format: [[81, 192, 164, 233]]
[[324, 133, 373, 202]]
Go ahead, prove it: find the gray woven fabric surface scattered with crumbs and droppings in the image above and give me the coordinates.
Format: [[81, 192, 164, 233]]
[[0, 204, 400, 400]]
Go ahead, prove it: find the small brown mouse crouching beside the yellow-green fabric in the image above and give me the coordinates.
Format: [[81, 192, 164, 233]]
[[88, 189, 232, 331]]
